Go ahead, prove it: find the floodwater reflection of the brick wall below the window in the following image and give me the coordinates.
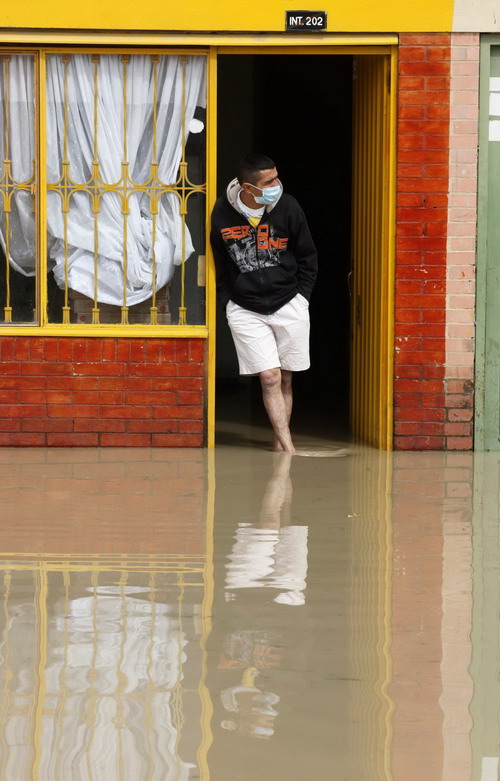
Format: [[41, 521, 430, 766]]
[[0, 450, 206, 556]]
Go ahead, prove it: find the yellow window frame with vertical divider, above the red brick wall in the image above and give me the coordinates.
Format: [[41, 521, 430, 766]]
[[0, 45, 216, 338]]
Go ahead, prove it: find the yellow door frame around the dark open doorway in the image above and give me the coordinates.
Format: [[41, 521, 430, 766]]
[[207, 35, 398, 450]]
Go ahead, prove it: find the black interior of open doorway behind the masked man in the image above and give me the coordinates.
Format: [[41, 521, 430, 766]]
[[216, 54, 353, 444]]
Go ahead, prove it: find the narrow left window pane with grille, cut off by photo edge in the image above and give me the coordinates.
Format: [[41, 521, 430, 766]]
[[0, 54, 37, 324]]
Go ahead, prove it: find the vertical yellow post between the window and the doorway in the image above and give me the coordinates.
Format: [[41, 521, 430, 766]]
[[205, 47, 217, 448]]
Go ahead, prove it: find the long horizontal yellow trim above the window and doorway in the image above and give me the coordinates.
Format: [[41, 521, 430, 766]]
[[0, 28, 398, 48]]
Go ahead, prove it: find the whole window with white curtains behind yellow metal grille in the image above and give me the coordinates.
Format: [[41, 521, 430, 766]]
[[0, 52, 206, 327]]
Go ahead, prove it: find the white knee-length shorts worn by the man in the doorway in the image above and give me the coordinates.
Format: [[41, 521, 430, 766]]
[[226, 293, 310, 374]]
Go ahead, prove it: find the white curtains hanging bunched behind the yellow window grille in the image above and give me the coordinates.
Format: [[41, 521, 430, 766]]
[[0, 54, 206, 306]]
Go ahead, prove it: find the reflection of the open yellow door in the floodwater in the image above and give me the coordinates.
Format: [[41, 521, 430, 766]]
[[349, 448, 395, 781]]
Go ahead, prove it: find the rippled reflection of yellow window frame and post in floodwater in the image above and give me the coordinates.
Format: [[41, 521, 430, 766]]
[[0, 451, 215, 781]]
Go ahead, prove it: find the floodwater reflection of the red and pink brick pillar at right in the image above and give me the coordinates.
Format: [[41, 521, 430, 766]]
[[389, 453, 472, 781]]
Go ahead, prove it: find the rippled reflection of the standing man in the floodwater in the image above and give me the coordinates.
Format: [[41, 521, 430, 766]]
[[218, 453, 308, 738]]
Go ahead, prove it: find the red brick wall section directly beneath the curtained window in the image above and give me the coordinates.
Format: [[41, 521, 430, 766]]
[[0, 336, 205, 447]]
